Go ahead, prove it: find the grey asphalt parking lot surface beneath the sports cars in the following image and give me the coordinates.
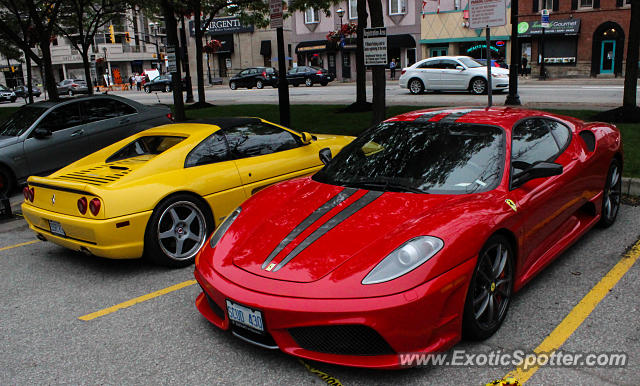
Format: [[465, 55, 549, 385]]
[[0, 199, 640, 385]]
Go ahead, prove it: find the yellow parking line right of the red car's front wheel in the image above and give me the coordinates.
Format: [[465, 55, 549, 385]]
[[503, 240, 640, 384]]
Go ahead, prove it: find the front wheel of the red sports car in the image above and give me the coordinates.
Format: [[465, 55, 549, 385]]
[[462, 235, 515, 340]]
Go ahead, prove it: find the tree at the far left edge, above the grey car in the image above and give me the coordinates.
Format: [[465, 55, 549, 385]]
[[0, 0, 60, 100]]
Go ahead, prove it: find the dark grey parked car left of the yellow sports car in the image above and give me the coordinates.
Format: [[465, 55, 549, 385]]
[[0, 95, 172, 194]]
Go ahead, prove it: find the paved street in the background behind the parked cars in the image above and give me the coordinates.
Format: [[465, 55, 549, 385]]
[[2, 79, 624, 110]]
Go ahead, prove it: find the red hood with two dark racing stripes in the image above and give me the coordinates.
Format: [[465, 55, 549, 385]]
[[230, 179, 466, 282]]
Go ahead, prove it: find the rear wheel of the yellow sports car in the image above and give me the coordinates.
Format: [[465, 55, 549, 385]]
[[144, 194, 213, 268]]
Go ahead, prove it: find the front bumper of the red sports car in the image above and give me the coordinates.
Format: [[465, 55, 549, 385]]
[[195, 258, 476, 368]]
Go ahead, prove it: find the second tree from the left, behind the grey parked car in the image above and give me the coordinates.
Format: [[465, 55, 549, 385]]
[[55, 0, 127, 94]]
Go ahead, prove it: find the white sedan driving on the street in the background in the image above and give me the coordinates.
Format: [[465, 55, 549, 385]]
[[398, 56, 509, 94]]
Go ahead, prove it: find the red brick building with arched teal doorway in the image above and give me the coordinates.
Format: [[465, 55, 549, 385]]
[[518, 0, 631, 78]]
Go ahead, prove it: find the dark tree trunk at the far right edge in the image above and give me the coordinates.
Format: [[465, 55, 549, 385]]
[[622, 0, 640, 110]]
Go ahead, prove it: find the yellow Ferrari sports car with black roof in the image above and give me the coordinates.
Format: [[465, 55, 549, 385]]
[[22, 118, 353, 267]]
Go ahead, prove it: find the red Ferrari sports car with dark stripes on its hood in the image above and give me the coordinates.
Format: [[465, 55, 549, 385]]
[[195, 108, 622, 368]]
